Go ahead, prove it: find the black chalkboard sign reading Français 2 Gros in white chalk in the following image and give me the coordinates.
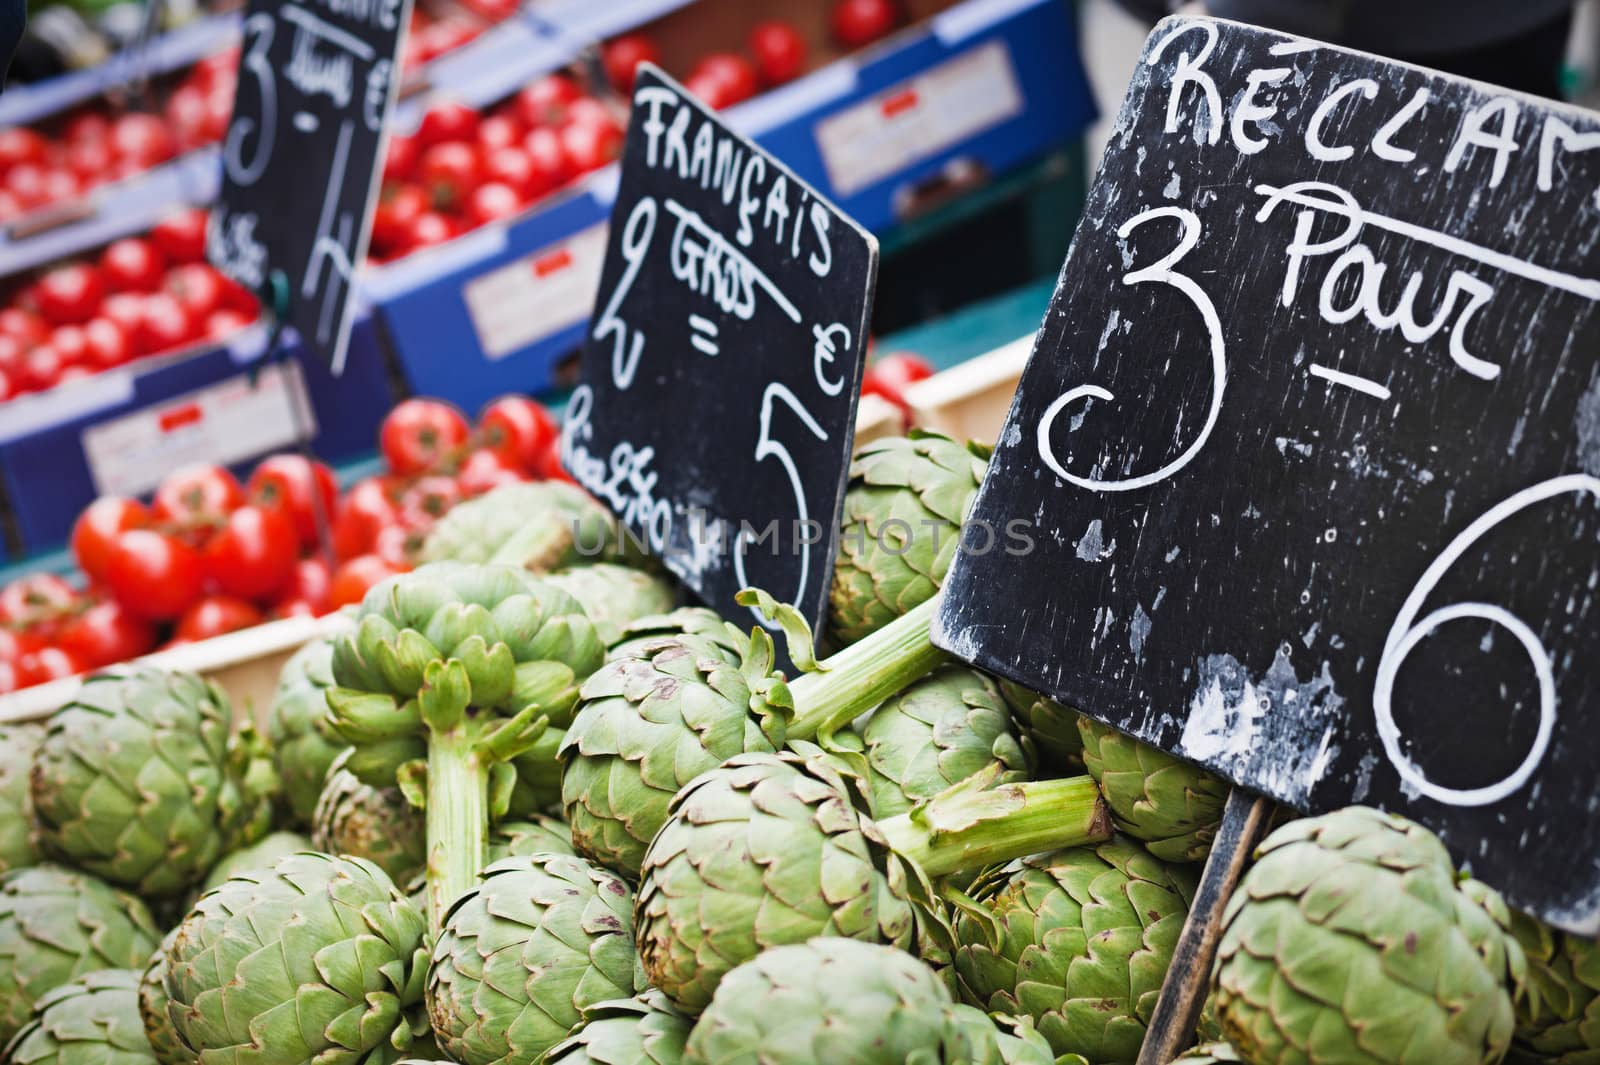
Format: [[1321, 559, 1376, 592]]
[[562, 67, 878, 642]]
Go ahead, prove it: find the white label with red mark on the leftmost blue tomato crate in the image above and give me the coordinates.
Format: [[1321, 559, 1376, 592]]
[[83, 363, 317, 496]]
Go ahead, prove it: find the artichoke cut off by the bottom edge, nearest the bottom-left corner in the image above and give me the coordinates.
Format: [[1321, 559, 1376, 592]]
[[3, 969, 157, 1065]]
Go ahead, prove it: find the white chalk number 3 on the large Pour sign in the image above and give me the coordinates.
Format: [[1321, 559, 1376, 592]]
[[1038, 206, 1227, 493]]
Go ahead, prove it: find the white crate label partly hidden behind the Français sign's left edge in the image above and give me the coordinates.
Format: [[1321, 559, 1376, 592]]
[[461, 222, 606, 358]]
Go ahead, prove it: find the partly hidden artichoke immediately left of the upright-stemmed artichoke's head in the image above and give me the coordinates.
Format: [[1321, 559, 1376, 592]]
[[267, 638, 349, 828]]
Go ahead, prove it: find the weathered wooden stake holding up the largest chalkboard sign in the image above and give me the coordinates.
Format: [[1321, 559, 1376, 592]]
[[1139, 788, 1272, 1065]]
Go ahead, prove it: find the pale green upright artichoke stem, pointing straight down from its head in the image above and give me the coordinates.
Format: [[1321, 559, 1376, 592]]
[[424, 715, 490, 935]]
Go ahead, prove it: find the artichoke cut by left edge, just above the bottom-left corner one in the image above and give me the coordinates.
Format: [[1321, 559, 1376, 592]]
[[0, 865, 160, 1044]]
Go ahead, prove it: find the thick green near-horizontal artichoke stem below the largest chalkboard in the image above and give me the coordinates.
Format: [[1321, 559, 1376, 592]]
[[877, 767, 1114, 878]]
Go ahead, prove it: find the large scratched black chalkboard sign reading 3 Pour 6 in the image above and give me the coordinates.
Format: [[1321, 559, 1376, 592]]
[[934, 19, 1600, 932]]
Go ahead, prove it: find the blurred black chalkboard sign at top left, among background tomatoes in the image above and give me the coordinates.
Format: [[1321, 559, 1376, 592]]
[[206, 0, 411, 374]]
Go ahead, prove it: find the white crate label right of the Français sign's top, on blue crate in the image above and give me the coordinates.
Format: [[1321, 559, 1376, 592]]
[[816, 40, 1022, 197]]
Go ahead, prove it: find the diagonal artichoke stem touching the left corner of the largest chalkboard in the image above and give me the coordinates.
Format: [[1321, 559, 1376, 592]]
[[786, 600, 946, 740]]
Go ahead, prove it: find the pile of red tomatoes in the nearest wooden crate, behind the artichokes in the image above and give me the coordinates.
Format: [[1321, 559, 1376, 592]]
[[0, 397, 565, 694]]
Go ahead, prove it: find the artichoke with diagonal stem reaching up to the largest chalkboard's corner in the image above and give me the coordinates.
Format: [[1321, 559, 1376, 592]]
[[560, 590, 944, 876]]
